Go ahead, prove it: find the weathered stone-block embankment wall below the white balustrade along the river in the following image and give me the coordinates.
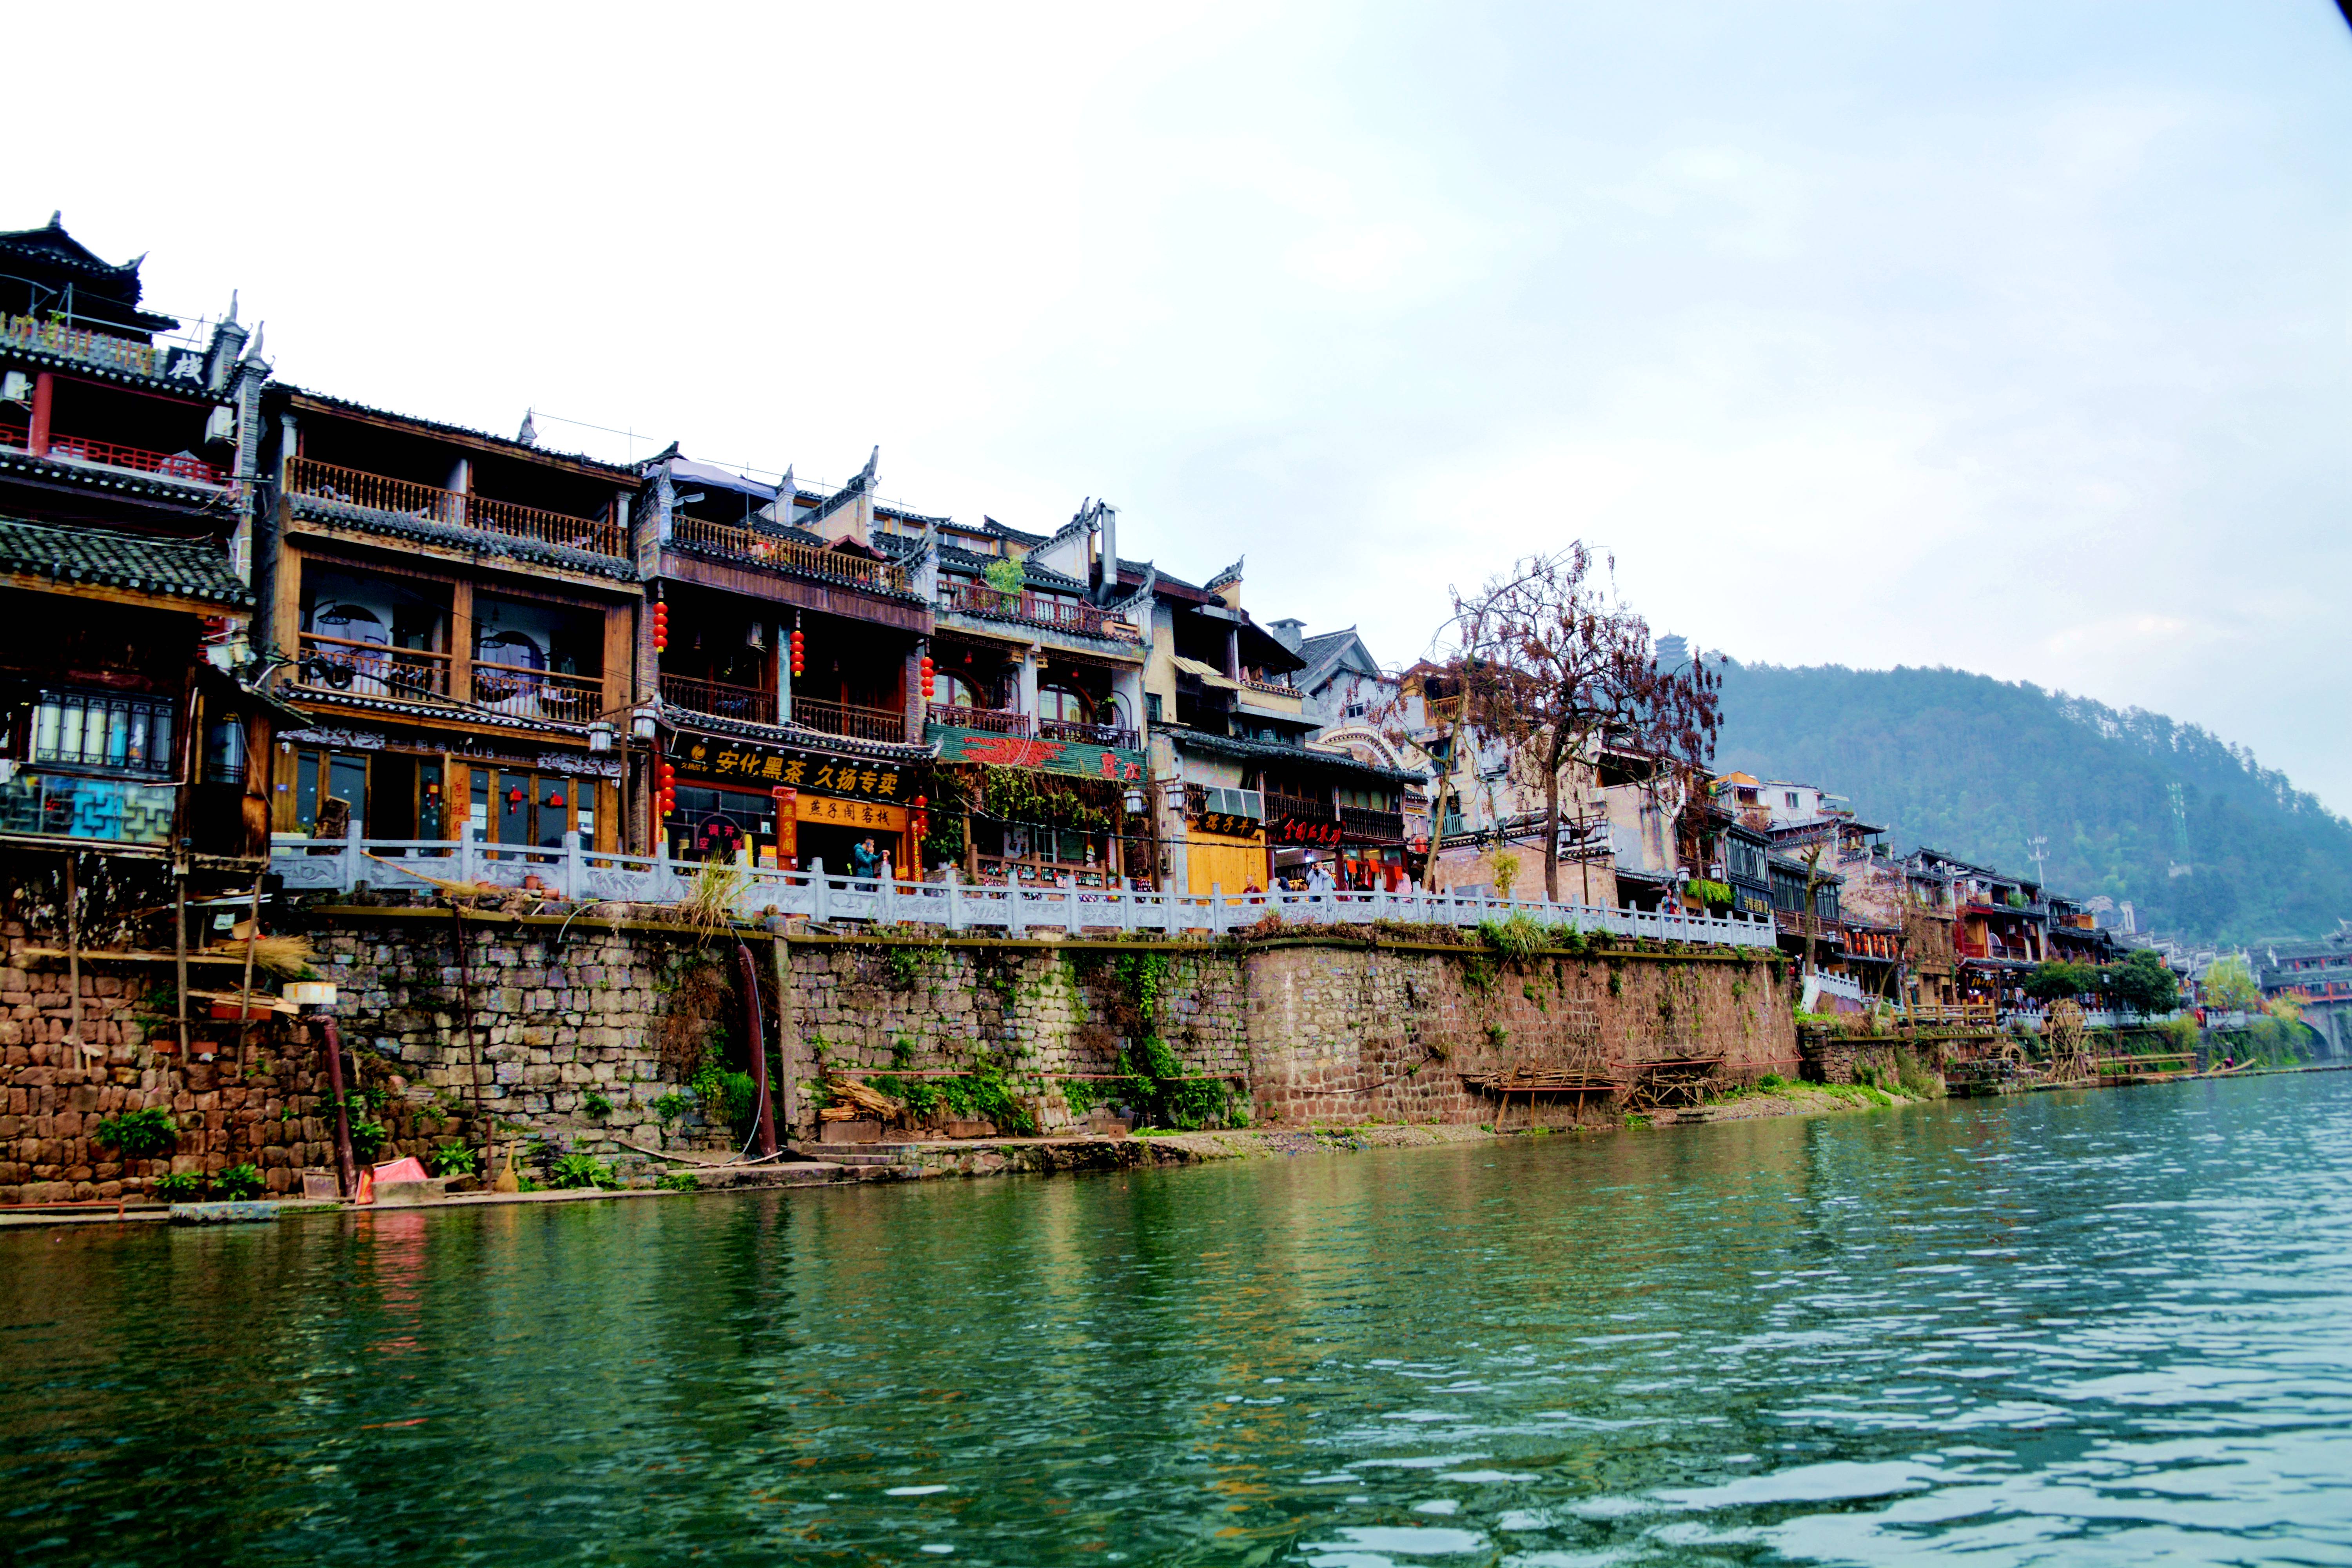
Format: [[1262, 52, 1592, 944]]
[[0, 910, 1797, 1203]]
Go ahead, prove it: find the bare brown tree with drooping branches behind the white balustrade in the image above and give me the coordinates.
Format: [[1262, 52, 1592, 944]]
[[1449, 541, 1722, 900]]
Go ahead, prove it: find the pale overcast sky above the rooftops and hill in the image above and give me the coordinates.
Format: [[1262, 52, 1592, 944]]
[[23, 0, 2352, 811]]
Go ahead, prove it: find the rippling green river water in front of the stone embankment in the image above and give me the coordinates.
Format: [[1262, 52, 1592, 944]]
[[0, 1074, 2352, 1568]]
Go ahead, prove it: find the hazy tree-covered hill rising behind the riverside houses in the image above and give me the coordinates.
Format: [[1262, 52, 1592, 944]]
[[1717, 663, 2352, 940]]
